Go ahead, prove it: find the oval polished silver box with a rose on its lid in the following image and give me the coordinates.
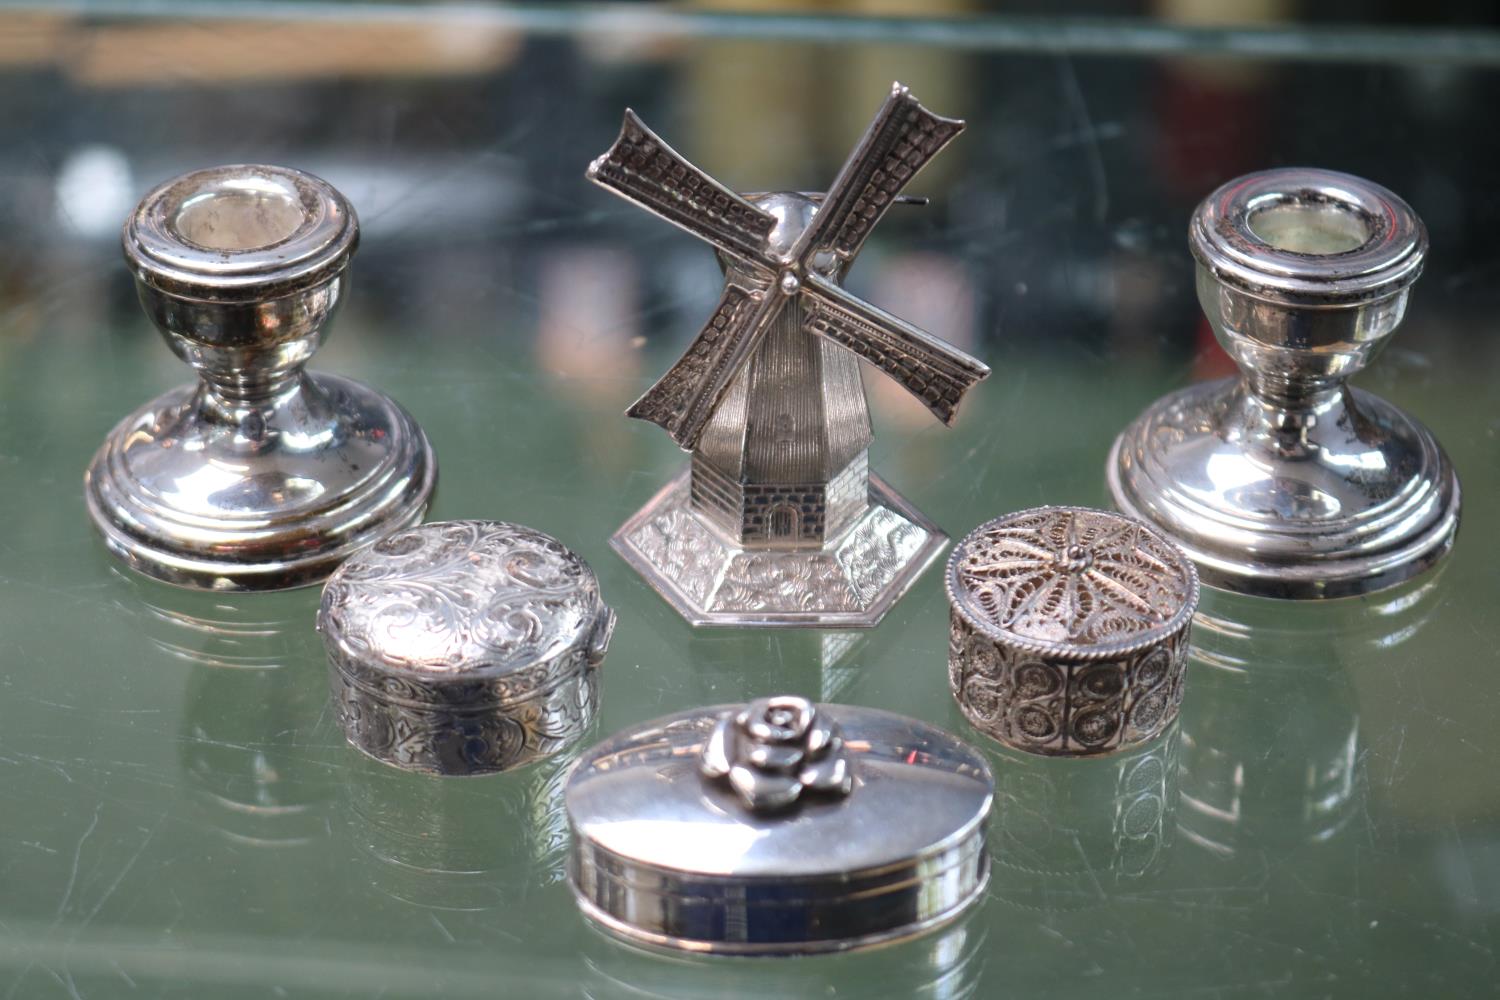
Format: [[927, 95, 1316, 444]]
[[563, 696, 995, 955]]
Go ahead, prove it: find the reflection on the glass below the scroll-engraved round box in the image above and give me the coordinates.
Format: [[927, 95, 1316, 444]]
[[341, 746, 576, 910]]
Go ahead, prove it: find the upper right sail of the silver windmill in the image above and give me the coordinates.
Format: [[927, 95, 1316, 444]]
[[789, 84, 963, 273]]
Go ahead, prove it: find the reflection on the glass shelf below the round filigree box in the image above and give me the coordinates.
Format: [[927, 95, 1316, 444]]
[[987, 726, 1179, 910]]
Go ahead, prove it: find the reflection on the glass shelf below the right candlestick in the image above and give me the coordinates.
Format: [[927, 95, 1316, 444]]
[[1178, 576, 1440, 858]]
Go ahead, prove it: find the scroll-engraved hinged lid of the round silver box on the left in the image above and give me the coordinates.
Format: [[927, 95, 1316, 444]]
[[318, 520, 614, 705]]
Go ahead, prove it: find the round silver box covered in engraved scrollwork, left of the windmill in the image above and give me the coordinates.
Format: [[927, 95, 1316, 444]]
[[318, 520, 615, 775]]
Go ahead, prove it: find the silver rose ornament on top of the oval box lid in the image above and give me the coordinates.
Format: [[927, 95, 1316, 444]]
[[699, 696, 854, 813]]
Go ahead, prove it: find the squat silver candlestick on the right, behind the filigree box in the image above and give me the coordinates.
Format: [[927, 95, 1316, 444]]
[[1107, 168, 1460, 598]]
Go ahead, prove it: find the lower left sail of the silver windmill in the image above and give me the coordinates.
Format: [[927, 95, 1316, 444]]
[[626, 282, 789, 450]]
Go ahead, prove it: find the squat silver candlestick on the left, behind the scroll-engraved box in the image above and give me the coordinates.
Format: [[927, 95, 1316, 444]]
[[84, 166, 437, 591]]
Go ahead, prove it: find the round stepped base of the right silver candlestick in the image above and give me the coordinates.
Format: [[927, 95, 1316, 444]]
[[1106, 379, 1460, 598]]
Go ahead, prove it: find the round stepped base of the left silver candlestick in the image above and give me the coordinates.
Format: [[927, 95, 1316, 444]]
[[84, 375, 437, 591]]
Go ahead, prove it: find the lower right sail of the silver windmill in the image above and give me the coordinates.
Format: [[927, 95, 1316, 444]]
[[801, 274, 990, 426]]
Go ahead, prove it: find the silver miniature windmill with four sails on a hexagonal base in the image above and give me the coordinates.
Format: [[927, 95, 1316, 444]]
[[588, 84, 989, 627]]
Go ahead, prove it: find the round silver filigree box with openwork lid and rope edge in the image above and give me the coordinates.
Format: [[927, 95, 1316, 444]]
[[947, 507, 1199, 756]]
